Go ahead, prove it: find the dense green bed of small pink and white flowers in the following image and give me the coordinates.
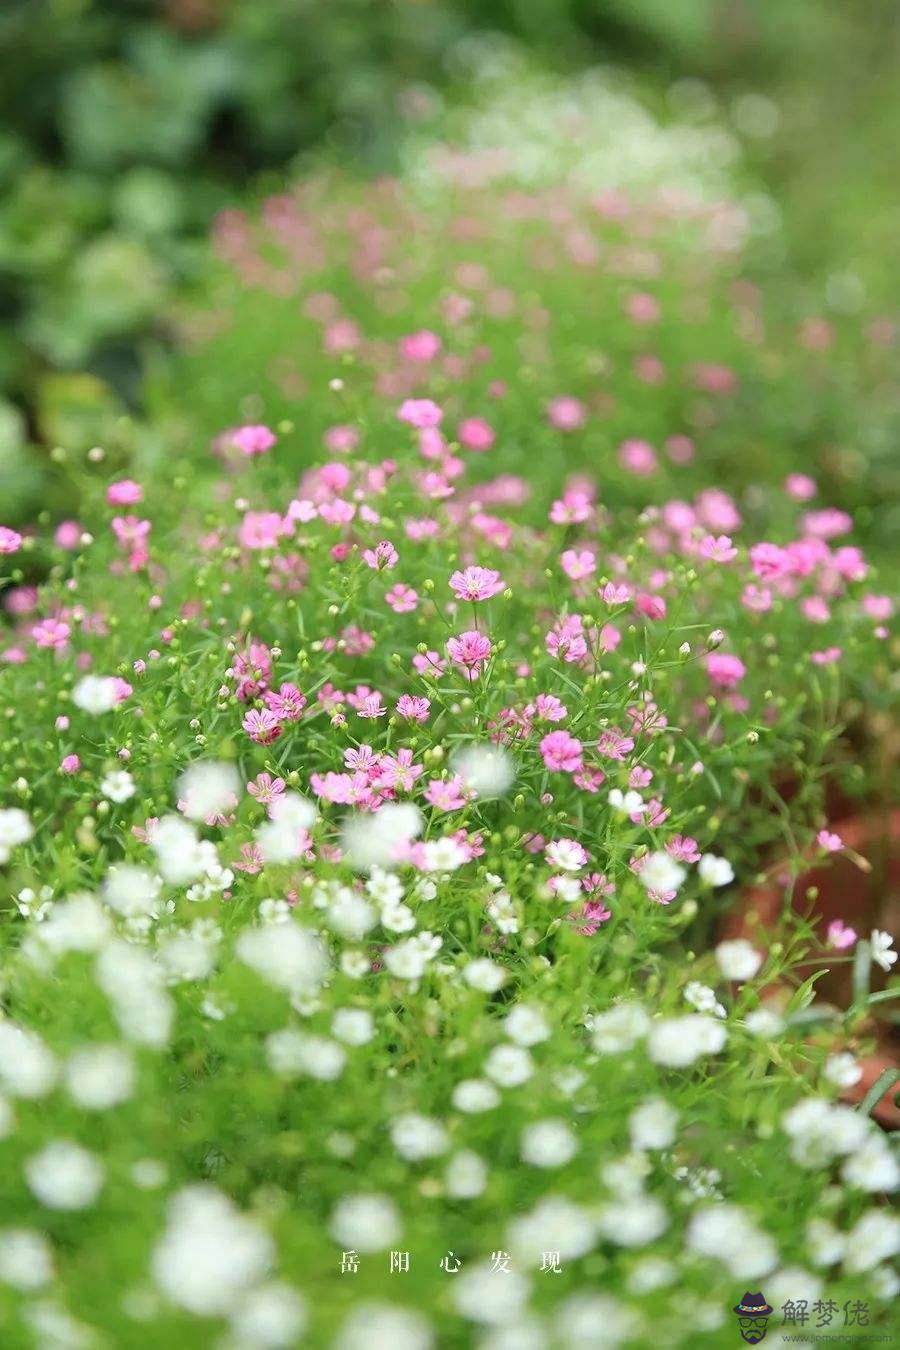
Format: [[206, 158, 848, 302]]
[[0, 159, 900, 1350]]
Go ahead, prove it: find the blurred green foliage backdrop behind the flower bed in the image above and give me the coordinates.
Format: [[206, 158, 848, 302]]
[[0, 0, 900, 524]]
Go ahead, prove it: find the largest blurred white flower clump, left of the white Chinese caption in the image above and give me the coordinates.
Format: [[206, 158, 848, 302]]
[[152, 1185, 274, 1318]]
